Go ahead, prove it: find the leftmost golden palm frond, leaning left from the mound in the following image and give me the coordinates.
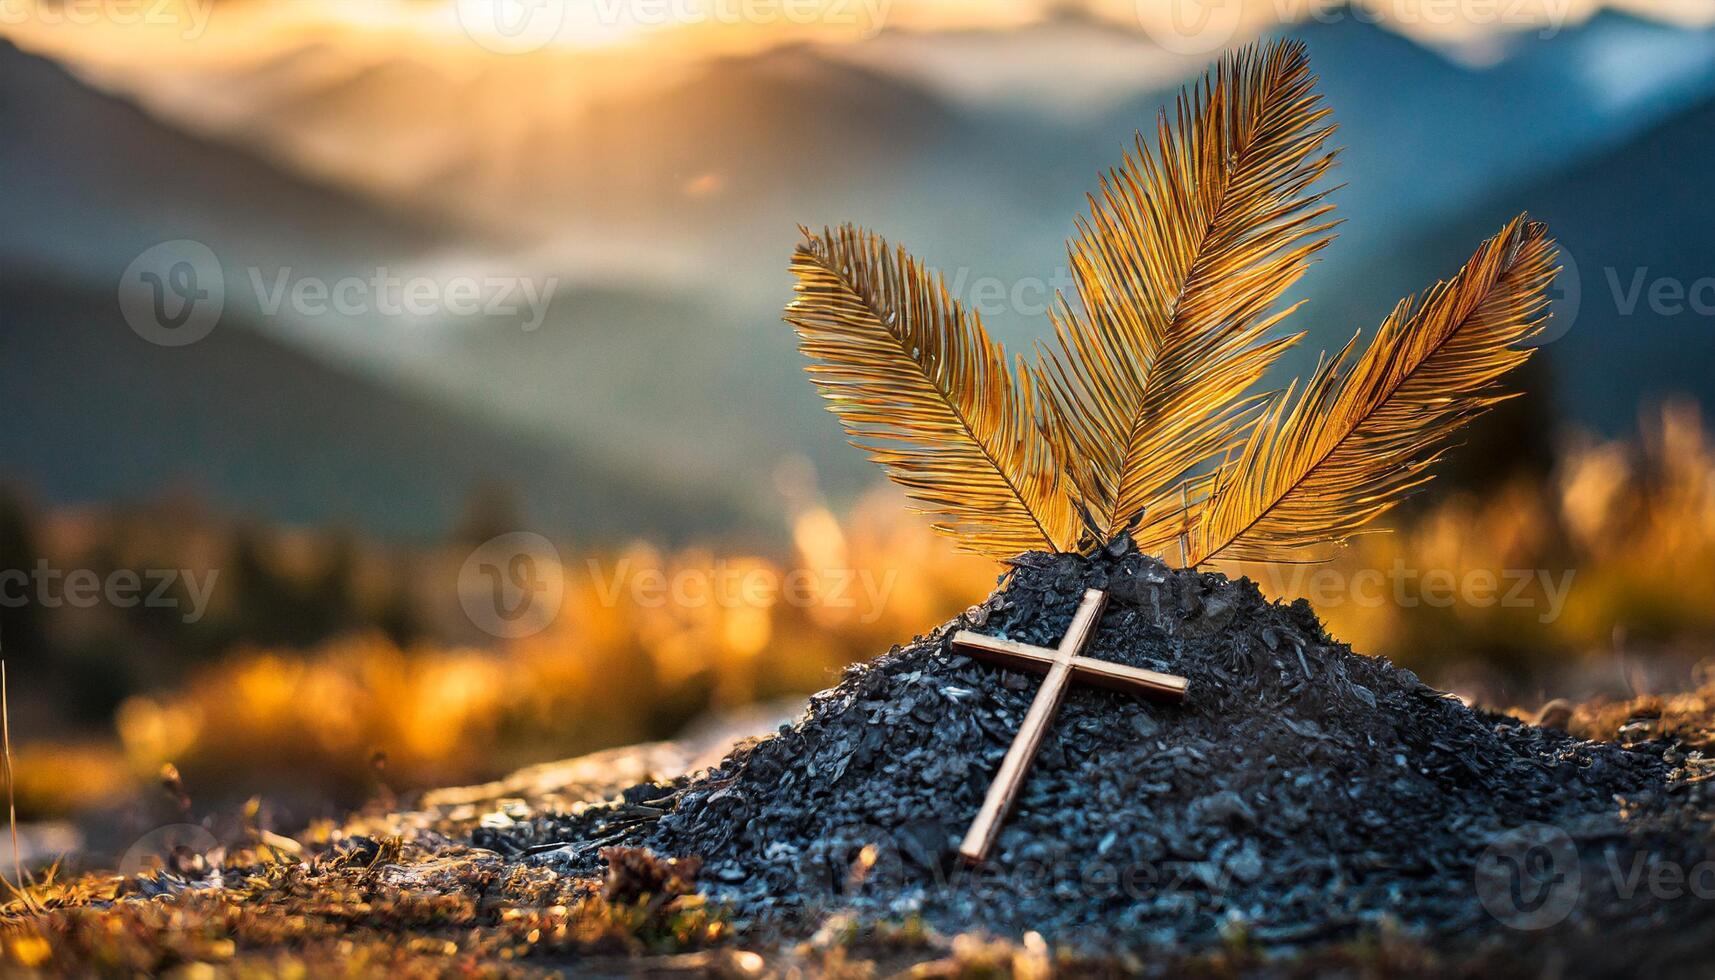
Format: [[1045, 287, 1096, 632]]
[[785, 225, 1079, 558]]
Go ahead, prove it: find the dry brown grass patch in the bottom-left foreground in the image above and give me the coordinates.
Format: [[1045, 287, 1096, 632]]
[[0, 838, 725, 977]]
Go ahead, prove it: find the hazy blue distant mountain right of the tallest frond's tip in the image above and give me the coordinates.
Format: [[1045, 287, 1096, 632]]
[[1302, 14, 1715, 255]]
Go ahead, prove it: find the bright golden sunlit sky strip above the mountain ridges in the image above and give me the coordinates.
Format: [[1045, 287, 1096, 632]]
[[0, 0, 1715, 65]]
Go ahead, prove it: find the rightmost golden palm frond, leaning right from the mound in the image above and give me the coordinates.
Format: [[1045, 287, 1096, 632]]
[[1187, 216, 1556, 565]]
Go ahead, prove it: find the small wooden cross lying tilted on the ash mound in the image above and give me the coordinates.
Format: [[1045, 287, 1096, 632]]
[[954, 589, 1188, 863]]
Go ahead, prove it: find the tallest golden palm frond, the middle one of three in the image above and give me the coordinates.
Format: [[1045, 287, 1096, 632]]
[[1041, 41, 1334, 551]]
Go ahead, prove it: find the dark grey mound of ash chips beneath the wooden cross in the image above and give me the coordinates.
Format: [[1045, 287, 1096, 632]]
[[475, 546, 1669, 947]]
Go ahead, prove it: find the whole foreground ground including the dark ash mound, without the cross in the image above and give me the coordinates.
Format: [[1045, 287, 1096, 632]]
[[3, 547, 1715, 975]]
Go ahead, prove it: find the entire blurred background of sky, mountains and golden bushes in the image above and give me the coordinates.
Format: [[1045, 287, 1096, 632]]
[[0, 0, 1715, 853]]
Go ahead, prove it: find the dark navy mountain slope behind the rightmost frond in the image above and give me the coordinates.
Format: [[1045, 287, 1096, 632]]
[[1322, 89, 1715, 434]]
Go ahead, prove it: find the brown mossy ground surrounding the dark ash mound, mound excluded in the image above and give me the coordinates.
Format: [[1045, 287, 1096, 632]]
[[3, 685, 1715, 977]]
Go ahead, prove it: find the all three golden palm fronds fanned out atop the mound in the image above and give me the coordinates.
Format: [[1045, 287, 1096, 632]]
[[787, 41, 1554, 565]]
